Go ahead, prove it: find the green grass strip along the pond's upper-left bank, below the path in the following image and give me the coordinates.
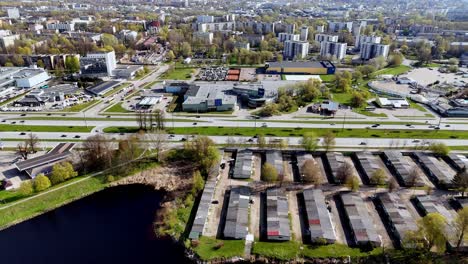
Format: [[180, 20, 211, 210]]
[[0, 177, 106, 229]]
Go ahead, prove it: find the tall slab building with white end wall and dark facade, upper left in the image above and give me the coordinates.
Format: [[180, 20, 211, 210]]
[[80, 51, 117, 77]]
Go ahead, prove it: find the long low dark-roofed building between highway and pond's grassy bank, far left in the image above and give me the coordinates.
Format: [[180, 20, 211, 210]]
[[15, 143, 75, 178]]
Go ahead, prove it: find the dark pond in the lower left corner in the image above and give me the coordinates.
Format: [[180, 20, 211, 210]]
[[0, 186, 190, 264]]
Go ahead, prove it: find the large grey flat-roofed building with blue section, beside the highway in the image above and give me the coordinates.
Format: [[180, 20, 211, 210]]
[[182, 85, 237, 112]]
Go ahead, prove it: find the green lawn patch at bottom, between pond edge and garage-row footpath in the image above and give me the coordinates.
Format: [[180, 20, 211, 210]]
[[194, 237, 245, 260]]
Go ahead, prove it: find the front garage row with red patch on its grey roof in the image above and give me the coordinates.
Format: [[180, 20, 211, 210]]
[[303, 189, 336, 243]]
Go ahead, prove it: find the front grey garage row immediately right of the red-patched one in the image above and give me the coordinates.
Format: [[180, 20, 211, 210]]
[[340, 193, 382, 247]]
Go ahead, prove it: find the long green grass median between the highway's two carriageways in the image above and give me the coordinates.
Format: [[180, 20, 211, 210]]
[[104, 126, 468, 139]]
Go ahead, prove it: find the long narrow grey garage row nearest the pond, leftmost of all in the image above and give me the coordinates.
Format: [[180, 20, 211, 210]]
[[189, 177, 216, 240]]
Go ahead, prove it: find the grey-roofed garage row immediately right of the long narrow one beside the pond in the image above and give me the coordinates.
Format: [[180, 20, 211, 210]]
[[223, 186, 250, 239]]
